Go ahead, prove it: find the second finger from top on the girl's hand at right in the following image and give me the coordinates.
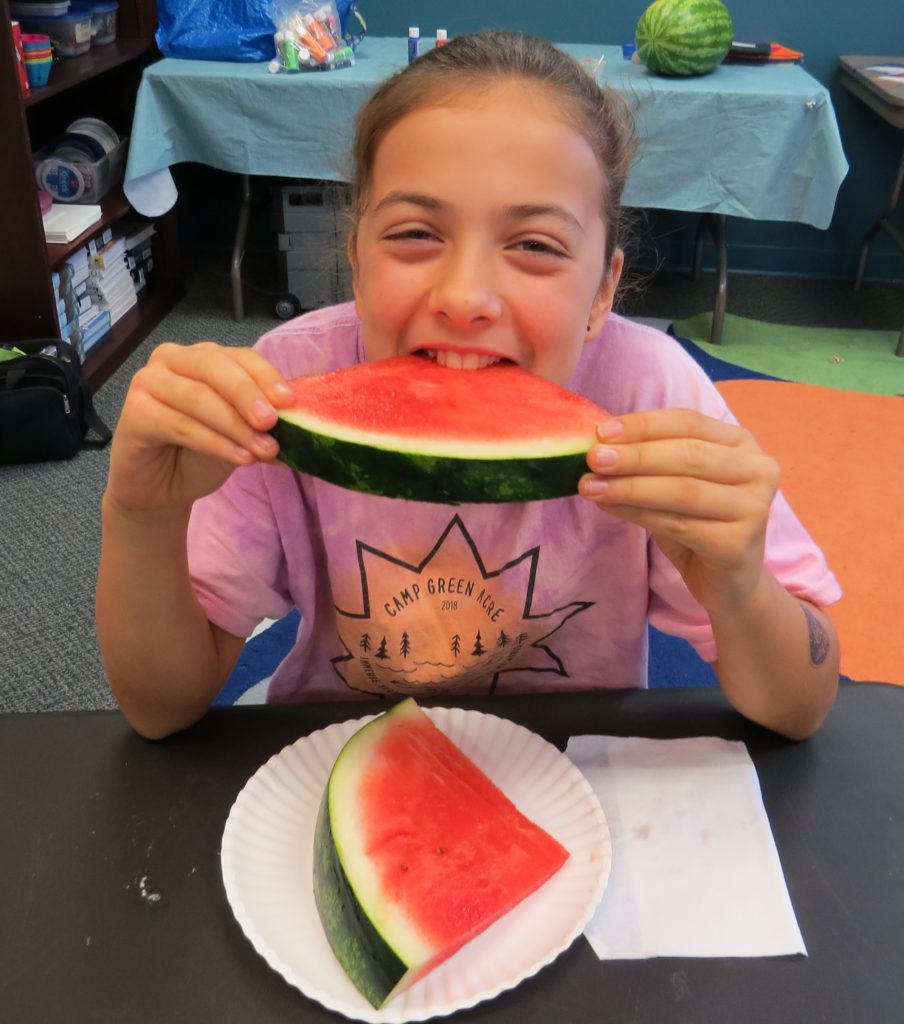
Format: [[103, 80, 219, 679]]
[[587, 437, 772, 484]]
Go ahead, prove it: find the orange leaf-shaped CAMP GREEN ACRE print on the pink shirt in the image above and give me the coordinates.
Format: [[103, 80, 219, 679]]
[[333, 515, 593, 695]]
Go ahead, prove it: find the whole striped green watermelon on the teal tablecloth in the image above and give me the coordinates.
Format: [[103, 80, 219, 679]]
[[635, 0, 734, 75]]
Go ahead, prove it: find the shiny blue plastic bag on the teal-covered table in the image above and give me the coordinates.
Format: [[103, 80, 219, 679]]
[[155, 0, 363, 63]]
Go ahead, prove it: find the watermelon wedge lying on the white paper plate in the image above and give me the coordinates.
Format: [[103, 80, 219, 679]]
[[313, 698, 568, 1009]]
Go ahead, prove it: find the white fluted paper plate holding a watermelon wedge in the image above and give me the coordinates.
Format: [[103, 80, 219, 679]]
[[221, 708, 612, 1024]]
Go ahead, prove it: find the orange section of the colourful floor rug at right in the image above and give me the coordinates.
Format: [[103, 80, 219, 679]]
[[716, 380, 904, 685]]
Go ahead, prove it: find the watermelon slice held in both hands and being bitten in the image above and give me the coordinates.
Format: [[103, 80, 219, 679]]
[[271, 355, 606, 505]]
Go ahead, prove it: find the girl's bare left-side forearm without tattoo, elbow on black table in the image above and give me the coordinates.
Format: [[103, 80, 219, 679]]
[[97, 502, 241, 738]]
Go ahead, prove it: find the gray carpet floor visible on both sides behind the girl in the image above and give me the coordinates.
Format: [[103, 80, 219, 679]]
[[0, 246, 904, 712]]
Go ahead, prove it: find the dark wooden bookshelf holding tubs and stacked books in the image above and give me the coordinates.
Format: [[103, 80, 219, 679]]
[[0, 0, 184, 387]]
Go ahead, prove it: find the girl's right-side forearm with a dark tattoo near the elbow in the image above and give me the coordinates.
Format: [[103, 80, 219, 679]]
[[711, 569, 838, 739]]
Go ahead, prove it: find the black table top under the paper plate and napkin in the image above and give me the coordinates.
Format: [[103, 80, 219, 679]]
[[0, 683, 904, 1024]]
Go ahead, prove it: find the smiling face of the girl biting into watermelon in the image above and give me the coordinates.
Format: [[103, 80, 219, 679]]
[[349, 83, 621, 384]]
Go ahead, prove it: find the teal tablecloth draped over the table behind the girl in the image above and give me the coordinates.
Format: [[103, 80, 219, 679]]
[[126, 37, 848, 228]]
